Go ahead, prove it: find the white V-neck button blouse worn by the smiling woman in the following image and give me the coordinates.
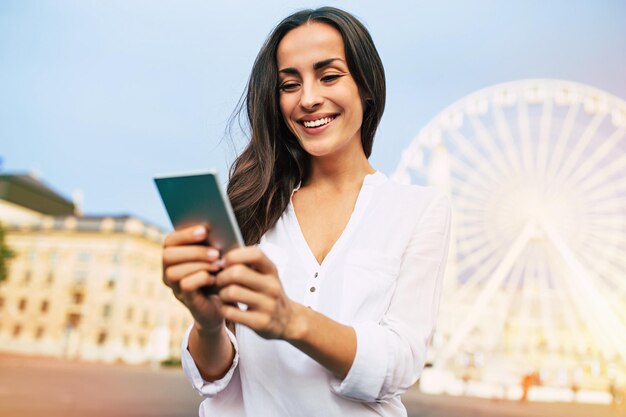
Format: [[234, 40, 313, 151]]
[[182, 172, 450, 417]]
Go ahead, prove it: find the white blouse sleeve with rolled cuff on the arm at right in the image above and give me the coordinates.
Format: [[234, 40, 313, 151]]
[[331, 195, 451, 402]]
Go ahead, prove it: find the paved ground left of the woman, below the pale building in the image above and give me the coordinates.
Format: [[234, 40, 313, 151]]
[[0, 356, 200, 417]]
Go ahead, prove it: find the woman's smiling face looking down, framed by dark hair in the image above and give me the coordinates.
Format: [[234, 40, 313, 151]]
[[277, 22, 363, 157]]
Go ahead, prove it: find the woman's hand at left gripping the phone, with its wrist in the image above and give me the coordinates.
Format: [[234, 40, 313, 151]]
[[163, 226, 224, 334]]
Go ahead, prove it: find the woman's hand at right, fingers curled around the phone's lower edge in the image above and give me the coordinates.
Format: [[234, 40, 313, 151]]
[[216, 246, 302, 340]]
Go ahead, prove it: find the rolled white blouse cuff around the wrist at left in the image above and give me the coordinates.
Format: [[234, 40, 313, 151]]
[[181, 324, 239, 398]]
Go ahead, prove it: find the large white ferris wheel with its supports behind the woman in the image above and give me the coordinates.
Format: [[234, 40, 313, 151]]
[[394, 79, 626, 394]]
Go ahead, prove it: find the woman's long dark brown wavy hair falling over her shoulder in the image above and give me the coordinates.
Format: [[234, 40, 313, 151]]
[[228, 7, 385, 245]]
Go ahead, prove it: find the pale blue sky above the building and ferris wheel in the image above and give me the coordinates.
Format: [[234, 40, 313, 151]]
[[0, 0, 626, 227]]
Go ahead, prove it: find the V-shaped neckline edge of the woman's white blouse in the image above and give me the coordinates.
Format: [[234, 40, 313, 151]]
[[288, 171, 385, 270]]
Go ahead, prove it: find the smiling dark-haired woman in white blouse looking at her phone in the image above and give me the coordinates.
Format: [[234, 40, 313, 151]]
[[163, 7, 450, 416]]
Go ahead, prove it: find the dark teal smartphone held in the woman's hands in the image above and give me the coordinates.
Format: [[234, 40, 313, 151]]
[[154, 171, 244, 254]]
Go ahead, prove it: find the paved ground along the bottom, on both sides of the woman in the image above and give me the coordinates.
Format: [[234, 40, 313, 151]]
[[0, 355, 626, 417]]
